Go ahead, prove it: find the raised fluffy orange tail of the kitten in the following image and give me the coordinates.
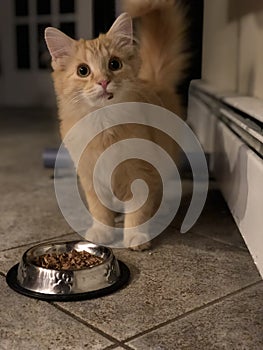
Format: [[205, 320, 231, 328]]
[[124, 0, 190, 91]]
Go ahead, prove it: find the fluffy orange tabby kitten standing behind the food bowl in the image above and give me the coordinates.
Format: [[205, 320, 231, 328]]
[[45, 0, 188, 250]]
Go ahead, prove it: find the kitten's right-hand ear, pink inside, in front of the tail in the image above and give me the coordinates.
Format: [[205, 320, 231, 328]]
[[107, 12, 133, 47]]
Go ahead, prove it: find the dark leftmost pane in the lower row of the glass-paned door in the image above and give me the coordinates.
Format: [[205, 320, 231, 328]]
[[16, 24, 30, 69]]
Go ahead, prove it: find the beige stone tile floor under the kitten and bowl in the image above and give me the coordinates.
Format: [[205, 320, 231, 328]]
[[0, 110, 263, 350]]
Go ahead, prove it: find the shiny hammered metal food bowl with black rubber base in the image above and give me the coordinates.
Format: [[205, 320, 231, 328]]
[[6, 241, 130, 301]]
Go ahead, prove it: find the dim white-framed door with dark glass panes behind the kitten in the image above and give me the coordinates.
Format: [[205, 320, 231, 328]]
[[0, 0, 93, 106]]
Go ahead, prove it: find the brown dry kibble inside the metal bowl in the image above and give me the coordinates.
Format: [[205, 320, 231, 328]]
[[33, 249, 103, 270]]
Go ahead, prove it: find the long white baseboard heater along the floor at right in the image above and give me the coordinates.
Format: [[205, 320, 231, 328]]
[[188, 81, 263, 277]]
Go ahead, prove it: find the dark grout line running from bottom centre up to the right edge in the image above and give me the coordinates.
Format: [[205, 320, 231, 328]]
[[120, 280, 263, 345]]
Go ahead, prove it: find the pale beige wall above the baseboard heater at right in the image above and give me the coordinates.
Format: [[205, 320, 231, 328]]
[[202, 0, 263, 99]]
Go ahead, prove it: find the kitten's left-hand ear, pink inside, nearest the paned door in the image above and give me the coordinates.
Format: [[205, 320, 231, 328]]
[[45, 27, 75, 69]]
